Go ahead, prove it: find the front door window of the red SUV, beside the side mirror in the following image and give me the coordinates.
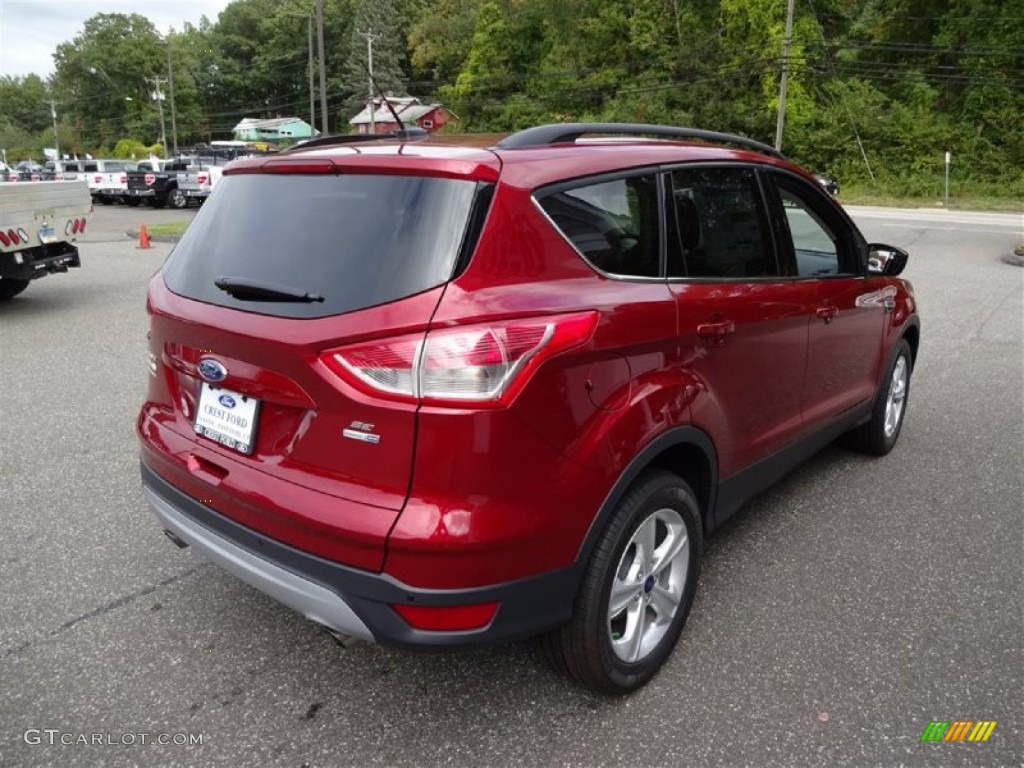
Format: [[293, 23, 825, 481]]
[[774, 174, 859, 278]]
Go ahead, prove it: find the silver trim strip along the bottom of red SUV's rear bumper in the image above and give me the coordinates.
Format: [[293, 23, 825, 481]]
[[142, 487, 374, 642]]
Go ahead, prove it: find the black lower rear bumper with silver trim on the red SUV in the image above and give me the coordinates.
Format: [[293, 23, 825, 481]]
[[141, 462, 579, 648]]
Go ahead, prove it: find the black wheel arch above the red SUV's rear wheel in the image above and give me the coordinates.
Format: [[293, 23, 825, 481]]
[[577, 426, 718, 565]]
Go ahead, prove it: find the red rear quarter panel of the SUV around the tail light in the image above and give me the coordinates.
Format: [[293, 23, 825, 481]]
[[385, 186, 695, 588]]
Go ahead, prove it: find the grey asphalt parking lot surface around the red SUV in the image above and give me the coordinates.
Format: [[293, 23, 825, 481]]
[[0, 201, 1024, 768]]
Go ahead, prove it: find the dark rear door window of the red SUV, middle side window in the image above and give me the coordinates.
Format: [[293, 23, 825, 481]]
[[667, 167, 779, 280]]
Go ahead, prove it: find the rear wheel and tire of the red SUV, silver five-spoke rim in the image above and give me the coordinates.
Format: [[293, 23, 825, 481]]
[[542, 470, 703, 693]]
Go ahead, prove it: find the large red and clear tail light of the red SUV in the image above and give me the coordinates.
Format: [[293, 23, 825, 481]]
[[321, 312, 598, 408]]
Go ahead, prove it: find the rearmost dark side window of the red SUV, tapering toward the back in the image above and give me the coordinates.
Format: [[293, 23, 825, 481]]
[[538, 175, 662, 278]]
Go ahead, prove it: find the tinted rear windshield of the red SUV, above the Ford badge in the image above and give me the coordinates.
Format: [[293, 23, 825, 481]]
[[163, 174, 476, 317]]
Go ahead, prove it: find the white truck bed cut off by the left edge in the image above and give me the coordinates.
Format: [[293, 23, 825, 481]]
[[0, 181, 92, 301]]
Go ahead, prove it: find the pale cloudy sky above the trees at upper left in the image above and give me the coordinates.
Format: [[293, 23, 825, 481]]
[[0, 0, 229, 78]]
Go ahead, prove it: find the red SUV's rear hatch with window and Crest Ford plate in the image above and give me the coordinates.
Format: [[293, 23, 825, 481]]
[[143, 156, 497, 568]]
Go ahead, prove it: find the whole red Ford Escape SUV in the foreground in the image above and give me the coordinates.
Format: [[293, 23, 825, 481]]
[[138, 124, 920, 692]]
